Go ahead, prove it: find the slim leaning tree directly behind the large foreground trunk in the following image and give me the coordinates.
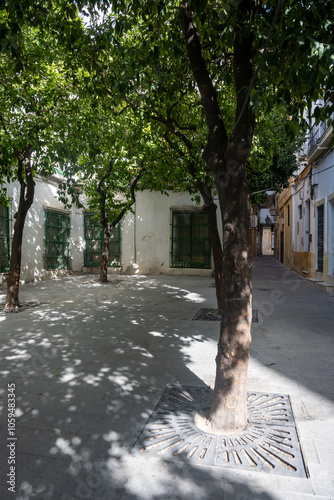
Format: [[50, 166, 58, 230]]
[[82, 4, 295, 314]]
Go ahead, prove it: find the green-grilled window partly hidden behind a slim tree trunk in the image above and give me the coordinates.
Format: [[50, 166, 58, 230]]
[[84, 214, 121, 267]]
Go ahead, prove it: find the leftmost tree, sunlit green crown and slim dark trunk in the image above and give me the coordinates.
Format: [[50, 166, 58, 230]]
[[0, 4, 83, 311]]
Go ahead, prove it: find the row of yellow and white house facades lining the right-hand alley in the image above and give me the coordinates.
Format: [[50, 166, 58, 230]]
[[275, 107, 334, 293]]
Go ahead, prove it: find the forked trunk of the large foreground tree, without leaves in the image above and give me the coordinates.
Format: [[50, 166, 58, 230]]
[[183, 0, 254, 434]]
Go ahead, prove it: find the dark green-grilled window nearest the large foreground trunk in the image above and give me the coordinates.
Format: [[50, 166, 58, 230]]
[[171, 210, 211, 269]]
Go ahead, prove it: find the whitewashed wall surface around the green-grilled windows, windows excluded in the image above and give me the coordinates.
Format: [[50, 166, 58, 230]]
[[0, 183, 221, 282]]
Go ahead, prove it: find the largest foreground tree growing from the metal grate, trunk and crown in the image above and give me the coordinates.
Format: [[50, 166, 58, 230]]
[[105, 0, 333, 433]]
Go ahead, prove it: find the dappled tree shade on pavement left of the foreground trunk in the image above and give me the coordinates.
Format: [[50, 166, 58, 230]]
[[0, 276, 271, 500]]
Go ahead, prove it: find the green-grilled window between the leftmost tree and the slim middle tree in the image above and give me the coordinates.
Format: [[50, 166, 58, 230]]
[[45, 210, 71, 269]]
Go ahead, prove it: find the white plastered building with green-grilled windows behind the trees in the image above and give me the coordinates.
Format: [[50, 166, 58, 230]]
[[0, 176, 221, 288]]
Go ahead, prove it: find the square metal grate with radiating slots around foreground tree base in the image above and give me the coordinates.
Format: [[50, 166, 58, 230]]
[[132, 386, 306, 477]]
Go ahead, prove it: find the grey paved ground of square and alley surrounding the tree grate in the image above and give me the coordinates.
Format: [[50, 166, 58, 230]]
[[0, 257, 334, 500]]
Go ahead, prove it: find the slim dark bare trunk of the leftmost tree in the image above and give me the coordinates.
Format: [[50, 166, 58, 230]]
[[5, 148, 35, 311]]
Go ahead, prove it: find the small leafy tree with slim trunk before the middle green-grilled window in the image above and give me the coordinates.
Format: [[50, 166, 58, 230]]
[[61, 19, 219, 290]]
